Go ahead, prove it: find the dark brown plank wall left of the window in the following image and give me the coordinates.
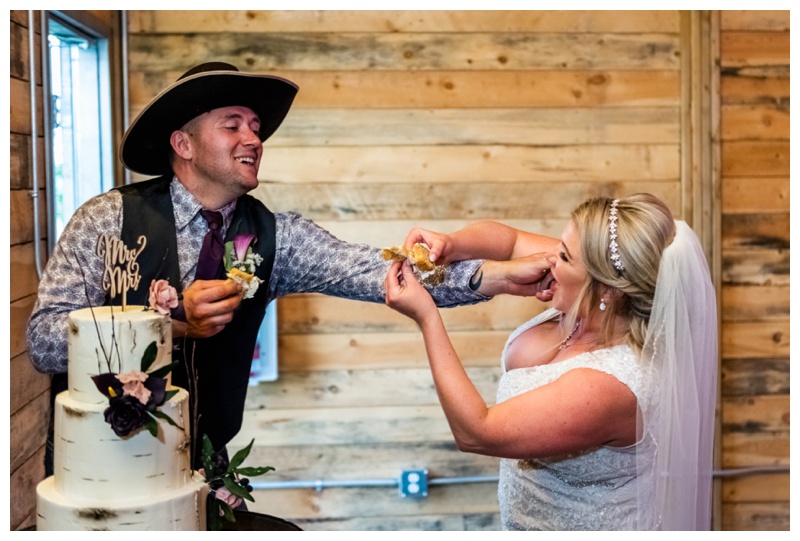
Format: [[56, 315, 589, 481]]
[[9, 10, 50, 530]]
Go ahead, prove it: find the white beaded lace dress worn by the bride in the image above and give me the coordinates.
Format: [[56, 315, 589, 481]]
[[497, 309, 655, 530]]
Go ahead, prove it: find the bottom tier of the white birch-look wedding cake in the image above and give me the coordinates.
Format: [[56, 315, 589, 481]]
[[36, 475, 208, 531]]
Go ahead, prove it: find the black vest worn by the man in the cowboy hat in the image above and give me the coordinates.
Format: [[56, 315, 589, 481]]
[[115, 176, 275, 467]]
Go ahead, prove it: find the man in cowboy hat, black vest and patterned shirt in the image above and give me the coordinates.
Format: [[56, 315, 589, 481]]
[[27, 62, 532, 467]]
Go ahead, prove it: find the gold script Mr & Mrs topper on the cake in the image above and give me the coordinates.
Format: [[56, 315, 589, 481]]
[[95, 234, 147, 311]]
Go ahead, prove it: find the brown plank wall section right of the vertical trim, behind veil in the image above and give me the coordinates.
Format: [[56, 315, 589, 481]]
[[720, 11, 790, 530]]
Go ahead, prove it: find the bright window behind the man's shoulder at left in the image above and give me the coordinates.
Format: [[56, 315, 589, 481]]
[[45, 12, 114, 245]]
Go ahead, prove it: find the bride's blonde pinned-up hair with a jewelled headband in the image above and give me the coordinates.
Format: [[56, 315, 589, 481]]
[[568, 193, 675, 354]]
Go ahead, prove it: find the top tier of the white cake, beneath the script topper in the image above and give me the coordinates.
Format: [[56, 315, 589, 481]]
[[68, 306, 172, 404]]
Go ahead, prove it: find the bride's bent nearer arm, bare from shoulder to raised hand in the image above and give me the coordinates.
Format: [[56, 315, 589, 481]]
[[386, 263, 636, 458]]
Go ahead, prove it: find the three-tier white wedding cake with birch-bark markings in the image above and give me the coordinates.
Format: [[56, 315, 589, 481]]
[[37, 306, 208, 530]]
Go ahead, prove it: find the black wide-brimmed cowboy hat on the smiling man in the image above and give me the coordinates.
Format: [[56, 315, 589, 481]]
[[120, 62, 297, 175]]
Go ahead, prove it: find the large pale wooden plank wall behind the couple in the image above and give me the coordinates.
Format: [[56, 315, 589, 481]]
[[123, 11, 681, 530]]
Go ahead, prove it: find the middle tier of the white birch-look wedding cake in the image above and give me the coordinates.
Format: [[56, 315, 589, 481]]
[[53, 387, 192, 503]]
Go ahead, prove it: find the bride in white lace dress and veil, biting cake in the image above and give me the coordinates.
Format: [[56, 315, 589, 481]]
[[386, 194, 717, 530]]
